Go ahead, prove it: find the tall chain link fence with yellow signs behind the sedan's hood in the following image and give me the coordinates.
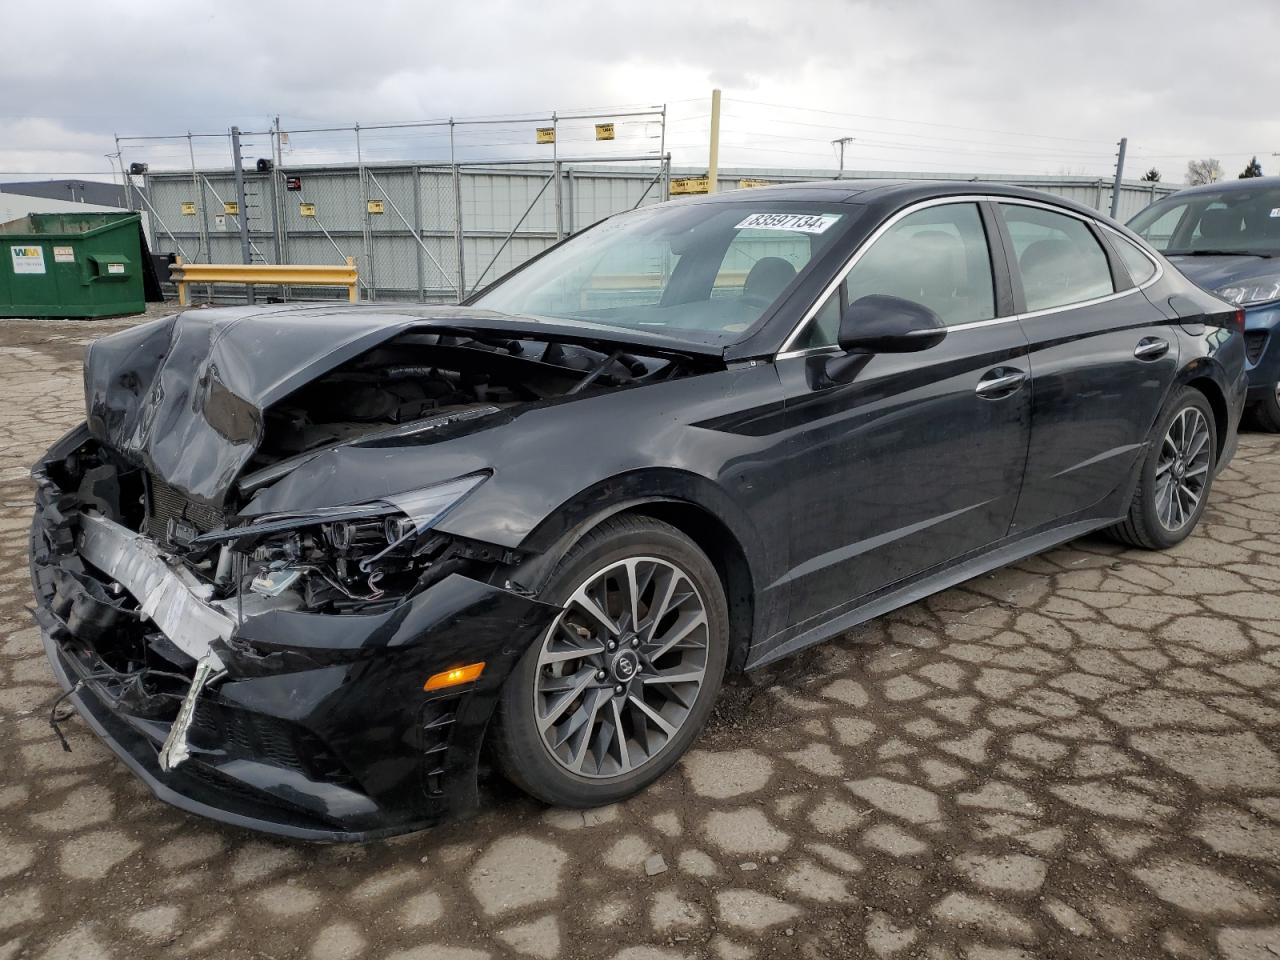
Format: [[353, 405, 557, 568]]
[[118, 108, 671, 303]]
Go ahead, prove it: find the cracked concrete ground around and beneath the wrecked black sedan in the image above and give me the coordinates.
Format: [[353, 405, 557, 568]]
[[0, 312, 1280, 960]]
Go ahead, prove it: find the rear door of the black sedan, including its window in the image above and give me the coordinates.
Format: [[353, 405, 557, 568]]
[[997, 200, 1178, 532]]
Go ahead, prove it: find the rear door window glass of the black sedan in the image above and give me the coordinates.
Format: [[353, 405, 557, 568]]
[[1000, 204, 1115, 312]]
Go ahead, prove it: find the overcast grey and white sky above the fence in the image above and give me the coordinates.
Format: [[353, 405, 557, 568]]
[[0, 0, 1280, 182]]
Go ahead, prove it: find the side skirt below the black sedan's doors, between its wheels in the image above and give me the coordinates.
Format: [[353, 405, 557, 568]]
[[744, 515, 1124, 669]]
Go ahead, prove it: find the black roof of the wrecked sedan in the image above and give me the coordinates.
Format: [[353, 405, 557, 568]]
[[677, 178, 1111, 223]]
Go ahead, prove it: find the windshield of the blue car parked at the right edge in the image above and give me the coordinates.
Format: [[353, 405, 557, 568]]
[[1129, 187, 1280, 256]]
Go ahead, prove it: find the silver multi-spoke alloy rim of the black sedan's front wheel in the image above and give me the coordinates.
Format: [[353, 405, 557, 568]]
[[534, 557, 709, 778]]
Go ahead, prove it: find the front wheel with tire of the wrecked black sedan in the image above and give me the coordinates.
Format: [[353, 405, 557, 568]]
[[493, 516, 728, 808]]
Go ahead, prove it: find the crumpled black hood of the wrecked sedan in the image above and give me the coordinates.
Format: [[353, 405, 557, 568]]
[[84, 303, 722, 504]]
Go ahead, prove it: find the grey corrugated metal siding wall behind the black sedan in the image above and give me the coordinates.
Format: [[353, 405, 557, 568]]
[[147, 164, 1178, 302]]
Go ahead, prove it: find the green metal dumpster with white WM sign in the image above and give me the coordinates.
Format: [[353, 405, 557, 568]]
[[0, 214, 146, 316]]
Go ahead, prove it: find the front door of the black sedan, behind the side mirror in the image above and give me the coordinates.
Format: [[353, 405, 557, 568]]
[[777, 198, 1030, 634]]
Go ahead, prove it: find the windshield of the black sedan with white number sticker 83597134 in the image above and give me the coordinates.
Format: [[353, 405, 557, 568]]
[[472, 201, 855, 343]]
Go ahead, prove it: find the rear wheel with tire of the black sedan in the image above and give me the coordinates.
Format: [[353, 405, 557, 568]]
[[1110, 387, 1217, 550]]
